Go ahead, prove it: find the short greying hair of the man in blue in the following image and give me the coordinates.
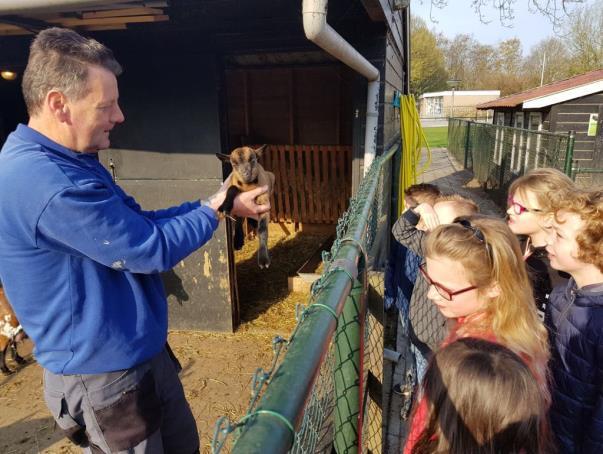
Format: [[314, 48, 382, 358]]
[[22, 27, 122, 117]]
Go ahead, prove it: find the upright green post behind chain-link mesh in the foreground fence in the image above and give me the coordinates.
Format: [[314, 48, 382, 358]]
[[334, 280, 363, 454]]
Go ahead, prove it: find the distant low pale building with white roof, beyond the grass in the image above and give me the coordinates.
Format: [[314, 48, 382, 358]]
[[419, 90, 500, 119]]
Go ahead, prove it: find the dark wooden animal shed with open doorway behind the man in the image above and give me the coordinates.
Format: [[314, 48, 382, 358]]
[[0, 0, 408, 331]]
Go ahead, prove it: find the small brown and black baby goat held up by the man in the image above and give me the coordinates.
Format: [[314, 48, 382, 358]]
[[216, 145, 274, 268]]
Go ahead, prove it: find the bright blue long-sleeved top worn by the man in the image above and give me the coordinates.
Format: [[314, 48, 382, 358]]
[[0, 125, 218, 374]]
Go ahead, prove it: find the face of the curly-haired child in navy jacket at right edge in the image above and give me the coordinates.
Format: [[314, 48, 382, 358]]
[[546, 211, 585, 274]]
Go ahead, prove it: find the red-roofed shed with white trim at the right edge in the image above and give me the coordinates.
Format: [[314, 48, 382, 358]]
[[477, 69, 603, 168]]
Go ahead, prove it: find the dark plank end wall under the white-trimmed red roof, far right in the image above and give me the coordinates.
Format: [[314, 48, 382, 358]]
[[551, 93, 603, 162]]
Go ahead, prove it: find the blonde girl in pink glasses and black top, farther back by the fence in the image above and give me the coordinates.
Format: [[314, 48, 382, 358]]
[[507, 168, 574, 318]]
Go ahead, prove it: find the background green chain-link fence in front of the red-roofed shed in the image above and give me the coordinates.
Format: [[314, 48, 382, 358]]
[[448, 118, 574, 207]]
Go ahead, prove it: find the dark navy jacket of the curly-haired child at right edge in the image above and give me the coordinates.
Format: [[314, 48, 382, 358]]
[[546, 279, 603, 454]]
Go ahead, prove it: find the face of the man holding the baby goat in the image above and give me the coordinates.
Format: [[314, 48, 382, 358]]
[[67, 66, 124, 153]]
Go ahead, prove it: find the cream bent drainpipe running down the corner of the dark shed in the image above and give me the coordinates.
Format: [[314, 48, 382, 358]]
[[302, 0, 379, 173]]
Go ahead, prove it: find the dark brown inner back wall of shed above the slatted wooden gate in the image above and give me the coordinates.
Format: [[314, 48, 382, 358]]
[[225, 65, 352, 148]]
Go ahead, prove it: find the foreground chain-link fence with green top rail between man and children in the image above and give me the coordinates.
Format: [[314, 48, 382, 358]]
[[212, 144, 400, 454]]
